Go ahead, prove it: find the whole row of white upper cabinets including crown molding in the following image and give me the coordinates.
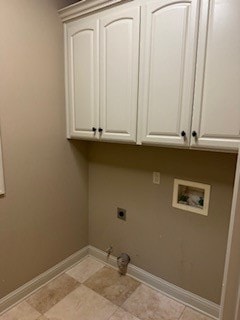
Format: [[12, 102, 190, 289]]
[[61, 0, 240, 151]]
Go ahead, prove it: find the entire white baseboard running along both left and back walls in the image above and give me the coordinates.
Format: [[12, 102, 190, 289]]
[[0, 246, 220, 319]]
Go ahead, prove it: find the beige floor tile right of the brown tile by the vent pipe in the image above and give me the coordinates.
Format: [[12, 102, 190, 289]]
[[122, 284, 185, 320]]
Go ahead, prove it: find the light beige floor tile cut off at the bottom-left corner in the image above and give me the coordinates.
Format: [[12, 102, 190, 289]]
[[0, 301, 40, 320]]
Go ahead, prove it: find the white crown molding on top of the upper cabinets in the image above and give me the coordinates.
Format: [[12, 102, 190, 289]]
[[58, 0, 133, 22]]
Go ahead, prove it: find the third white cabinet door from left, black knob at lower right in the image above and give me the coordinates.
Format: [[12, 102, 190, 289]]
[[138, 0, 199, 146]]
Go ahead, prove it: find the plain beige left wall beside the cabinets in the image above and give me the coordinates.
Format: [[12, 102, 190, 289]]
[[0, 0, 88, 298]]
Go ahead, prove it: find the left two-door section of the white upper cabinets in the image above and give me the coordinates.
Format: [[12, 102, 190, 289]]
[[65, 3, 140, 142]]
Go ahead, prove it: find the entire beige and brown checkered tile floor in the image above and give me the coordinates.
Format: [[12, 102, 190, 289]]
[[0, 257, 214, 320]]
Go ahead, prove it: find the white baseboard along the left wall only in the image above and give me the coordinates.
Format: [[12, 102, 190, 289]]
[[0, 246, 88, 315]]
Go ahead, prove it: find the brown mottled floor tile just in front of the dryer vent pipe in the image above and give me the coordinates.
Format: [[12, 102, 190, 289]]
[[84, 267, 140, 306]]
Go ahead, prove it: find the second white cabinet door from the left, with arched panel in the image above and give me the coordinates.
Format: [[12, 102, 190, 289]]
[[100, 7, 140, 142]]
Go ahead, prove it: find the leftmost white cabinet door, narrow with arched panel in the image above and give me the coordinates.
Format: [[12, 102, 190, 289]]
[[65, 19, 99, 139]]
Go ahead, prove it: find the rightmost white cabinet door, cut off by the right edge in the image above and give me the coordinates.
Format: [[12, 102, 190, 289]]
[[191, 0, 240, 149]]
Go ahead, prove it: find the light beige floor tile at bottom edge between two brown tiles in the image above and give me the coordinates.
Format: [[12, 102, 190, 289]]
[[45, 285, 117, 320]]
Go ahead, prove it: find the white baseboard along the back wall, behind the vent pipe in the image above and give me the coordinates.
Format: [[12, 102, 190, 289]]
[[88, 246, 220, 319]]
